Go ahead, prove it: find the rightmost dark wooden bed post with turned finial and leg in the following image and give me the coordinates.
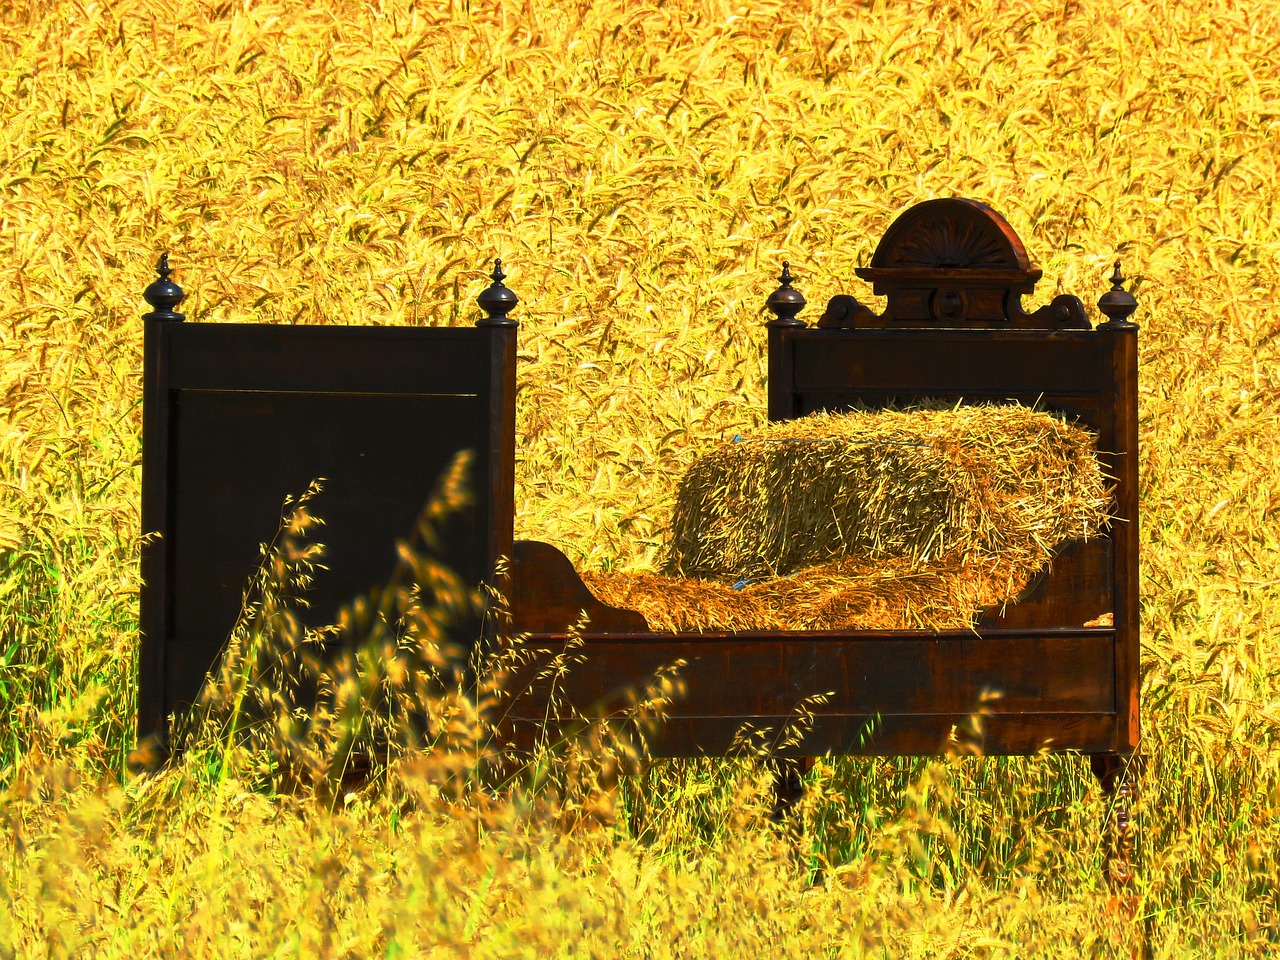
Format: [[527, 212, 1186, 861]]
[[1089, 260, 1142, 887]]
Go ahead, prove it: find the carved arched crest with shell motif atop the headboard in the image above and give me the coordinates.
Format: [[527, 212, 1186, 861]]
[[798, 197, 1089, 330]]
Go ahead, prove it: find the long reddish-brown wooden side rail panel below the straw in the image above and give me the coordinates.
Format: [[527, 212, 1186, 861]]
[[504, 627, 1115, 717]]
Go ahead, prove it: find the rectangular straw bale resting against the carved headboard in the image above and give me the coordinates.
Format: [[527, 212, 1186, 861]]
[[664, 404, 1106, 580]]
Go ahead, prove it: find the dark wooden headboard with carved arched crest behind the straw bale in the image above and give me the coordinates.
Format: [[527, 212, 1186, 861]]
[[768, 197, 1139, 744]]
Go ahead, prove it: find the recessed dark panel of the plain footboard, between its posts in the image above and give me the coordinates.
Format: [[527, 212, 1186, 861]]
[[170, 390, 486, 655]]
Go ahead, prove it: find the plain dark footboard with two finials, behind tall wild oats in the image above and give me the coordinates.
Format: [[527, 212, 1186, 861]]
[[138, 259, 516, 739]]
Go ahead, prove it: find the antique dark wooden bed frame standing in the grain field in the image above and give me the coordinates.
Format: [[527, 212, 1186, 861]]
[[140, 198, 1139, 880]]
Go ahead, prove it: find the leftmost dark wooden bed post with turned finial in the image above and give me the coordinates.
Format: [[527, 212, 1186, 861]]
[[137, 253, 187, 765]]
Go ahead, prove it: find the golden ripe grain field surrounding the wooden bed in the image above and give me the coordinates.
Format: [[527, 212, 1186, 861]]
[[0, 0, 1280, 957]]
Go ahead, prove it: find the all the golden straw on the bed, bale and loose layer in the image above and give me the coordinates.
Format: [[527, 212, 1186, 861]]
[[584, 406, 1107, 631]]
